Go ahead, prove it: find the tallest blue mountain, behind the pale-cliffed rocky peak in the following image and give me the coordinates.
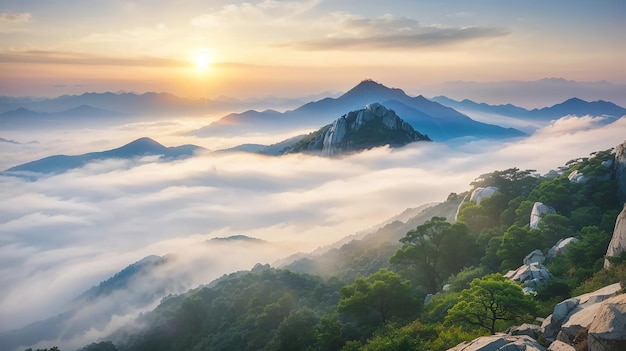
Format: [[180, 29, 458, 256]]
[[191, 80, 524, 141]]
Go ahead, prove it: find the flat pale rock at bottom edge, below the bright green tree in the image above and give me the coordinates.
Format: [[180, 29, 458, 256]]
[[448, 335, 546, 351]]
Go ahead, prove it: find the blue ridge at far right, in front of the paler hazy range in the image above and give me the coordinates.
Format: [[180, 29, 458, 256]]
[[431, 96, 626, 121]]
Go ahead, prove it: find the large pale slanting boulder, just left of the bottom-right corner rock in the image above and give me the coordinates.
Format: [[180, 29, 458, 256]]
[[541, 283, 622, 342]]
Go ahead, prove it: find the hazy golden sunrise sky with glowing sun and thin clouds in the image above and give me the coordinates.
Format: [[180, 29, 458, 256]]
[[0, 0, 626, 97]]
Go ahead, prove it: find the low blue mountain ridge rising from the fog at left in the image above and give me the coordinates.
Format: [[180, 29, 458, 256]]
[[5, 137, 204, 173]]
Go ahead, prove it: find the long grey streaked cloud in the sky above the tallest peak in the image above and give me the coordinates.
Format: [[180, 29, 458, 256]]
[[278, 13, 508, 50]]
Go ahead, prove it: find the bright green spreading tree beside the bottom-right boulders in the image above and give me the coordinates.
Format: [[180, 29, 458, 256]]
[[446, 274, 537, 335]]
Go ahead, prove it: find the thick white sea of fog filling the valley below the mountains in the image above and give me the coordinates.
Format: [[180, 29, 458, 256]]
[[0, 117, 626, 346]]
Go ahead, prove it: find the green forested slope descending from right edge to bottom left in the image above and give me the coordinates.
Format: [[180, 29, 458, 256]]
[[83, 150, 626, 351]]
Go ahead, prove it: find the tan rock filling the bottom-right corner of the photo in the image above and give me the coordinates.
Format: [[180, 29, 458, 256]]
[[587, 294, 626, 351]]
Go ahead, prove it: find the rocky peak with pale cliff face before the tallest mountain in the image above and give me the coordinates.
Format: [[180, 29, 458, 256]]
[[284, 103, 430, 157]]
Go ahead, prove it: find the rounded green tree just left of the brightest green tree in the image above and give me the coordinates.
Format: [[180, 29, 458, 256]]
[[337, 269, 420, 325]]
